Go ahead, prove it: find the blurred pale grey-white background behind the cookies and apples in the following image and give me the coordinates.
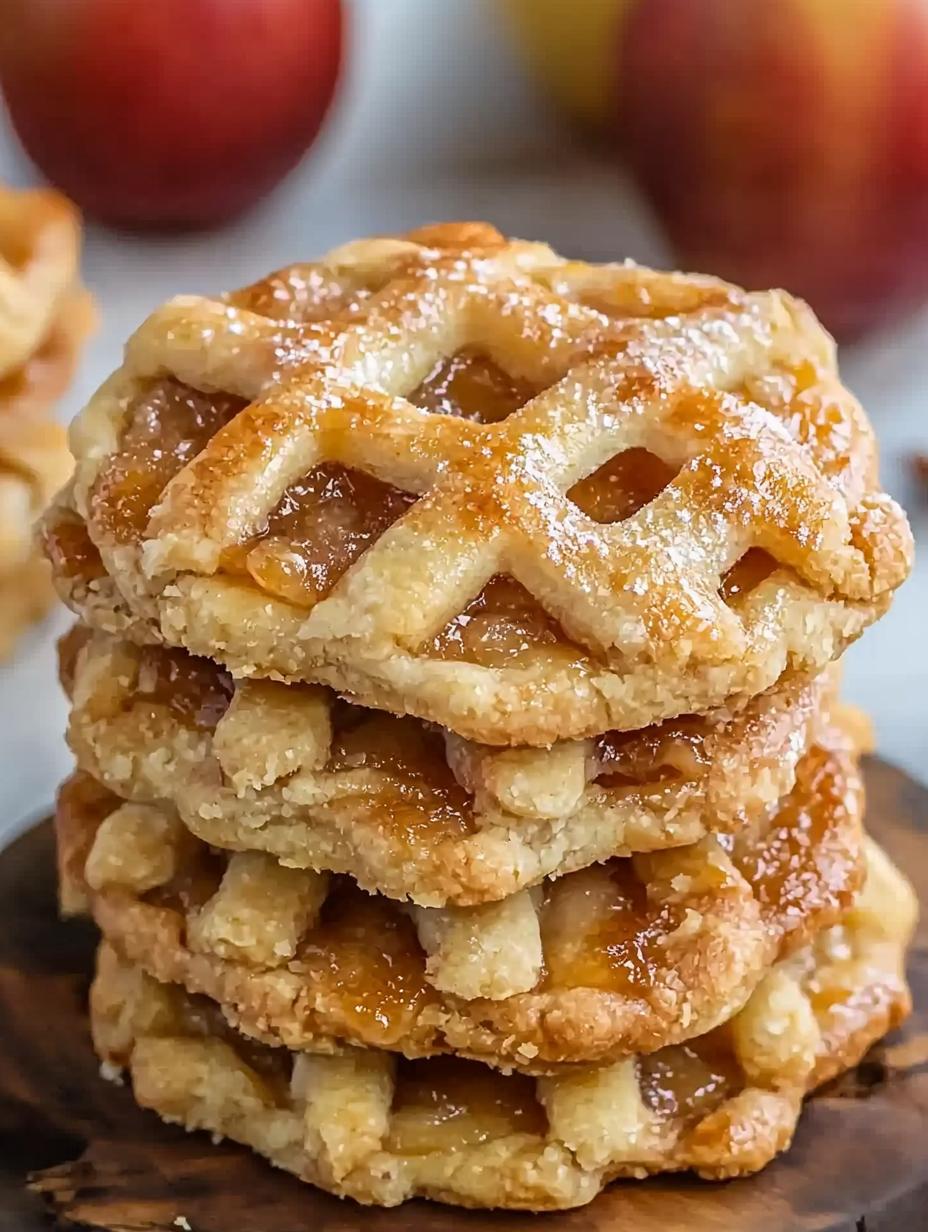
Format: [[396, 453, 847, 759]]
[[0, 0, 928, 840]]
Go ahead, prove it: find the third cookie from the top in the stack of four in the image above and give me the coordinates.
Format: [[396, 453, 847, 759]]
[[58, 719, 861, 1071]]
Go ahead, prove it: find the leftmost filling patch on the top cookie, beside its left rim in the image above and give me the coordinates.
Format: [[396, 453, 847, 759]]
[[90, 379, 242, 543]]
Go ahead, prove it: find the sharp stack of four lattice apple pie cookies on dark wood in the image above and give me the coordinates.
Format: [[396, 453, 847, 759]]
[[44, 224, 914, 1210]]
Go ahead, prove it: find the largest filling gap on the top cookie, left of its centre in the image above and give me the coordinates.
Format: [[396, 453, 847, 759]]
[[223, 463, 417, 607]]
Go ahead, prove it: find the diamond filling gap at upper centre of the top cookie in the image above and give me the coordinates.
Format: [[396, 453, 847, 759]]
[[408, 346, 541, 424]]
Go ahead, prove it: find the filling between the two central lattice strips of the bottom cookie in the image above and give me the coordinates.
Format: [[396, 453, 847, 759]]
[[385, 1057, 547, 1156]]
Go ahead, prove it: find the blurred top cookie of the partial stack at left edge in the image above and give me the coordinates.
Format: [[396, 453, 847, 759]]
[[0, 185, 80, 381]]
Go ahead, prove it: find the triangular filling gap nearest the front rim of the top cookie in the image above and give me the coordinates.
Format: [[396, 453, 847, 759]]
[[430, 574, 585, 668]]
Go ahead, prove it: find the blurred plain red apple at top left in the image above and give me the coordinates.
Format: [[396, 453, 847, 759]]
[[0, 0, 343, 225]]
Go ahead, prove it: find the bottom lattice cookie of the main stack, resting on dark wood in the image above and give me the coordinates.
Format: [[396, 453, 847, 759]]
[[91, 846, 916, 1210]]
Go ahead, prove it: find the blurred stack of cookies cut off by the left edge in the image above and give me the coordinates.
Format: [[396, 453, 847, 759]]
[[0, 185, 92, 659]]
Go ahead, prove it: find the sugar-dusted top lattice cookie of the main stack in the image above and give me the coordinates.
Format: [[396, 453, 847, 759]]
[[48, 224, 911, 744]]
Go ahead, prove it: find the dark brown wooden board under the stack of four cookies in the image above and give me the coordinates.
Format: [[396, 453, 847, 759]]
[[0, 761, 928, 1232]]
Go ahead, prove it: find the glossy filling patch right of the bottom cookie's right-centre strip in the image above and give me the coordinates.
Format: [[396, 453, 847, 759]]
[[638, 1027, 744, 1120]]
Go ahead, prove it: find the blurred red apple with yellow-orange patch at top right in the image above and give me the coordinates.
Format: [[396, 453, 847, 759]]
[[617, 0, 928, 335]]
